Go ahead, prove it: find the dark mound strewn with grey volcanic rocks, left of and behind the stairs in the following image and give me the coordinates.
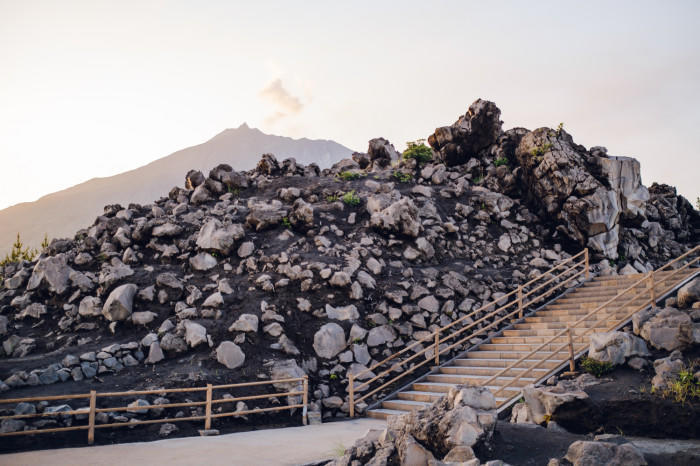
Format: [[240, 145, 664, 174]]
[[0, 100, 700, 448]]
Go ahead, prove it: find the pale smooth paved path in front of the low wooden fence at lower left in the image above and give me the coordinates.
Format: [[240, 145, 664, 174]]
[[0, 418, 386, 466]]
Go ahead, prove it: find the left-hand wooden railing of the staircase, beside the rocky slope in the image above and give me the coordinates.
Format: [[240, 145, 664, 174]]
[[348, 248, 589, 417]]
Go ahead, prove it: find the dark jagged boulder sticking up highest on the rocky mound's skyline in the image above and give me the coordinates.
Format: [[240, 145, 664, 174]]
[[428, 99, 503, 165]]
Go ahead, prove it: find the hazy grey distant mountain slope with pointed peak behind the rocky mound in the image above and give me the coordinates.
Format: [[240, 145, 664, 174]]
[[0, 123, 352, 255]]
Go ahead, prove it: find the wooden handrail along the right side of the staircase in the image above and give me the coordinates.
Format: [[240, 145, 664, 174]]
[[481, 245, 700, 396]]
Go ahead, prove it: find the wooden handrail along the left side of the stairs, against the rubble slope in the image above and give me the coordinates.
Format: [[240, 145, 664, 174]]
[[348, 248, 589, 417]]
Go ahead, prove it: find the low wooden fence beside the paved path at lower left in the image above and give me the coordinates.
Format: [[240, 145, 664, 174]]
[[0, 376, 309, 445]]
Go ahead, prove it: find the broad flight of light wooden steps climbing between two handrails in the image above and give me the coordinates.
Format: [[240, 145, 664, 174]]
[[367, 264, 699, 418]]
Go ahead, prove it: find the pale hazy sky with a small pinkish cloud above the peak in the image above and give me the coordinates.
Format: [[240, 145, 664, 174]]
[[0, 0, 700, 208]]
